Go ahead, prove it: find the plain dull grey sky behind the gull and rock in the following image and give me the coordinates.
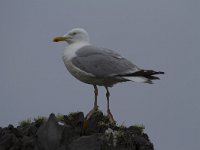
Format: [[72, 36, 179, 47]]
[[0, 0, 200, 150]]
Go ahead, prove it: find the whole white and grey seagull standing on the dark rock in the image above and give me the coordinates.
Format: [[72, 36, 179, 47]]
[[53, 28, 164, 123]]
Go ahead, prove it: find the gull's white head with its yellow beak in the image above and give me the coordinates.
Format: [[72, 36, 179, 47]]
[[53, 28, 90, 44]]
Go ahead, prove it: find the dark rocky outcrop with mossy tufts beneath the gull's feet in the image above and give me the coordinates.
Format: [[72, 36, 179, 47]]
[[0, 112, 153, 150]]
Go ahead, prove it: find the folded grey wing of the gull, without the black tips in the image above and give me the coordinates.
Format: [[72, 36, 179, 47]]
[[72, 46, 139, 77]]
